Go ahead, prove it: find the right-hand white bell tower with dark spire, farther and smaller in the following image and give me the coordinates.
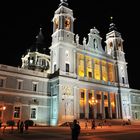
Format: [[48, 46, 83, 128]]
[[105, 18, 129, 87]]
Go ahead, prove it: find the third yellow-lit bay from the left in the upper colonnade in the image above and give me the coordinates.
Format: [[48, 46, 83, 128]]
[[94, 59, 100, 80]]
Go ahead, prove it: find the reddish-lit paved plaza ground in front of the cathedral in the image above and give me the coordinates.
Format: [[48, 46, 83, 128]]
[[0, 119, 140, 140]]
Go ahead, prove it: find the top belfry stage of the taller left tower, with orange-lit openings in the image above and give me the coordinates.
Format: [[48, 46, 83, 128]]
[[52, 0, 74, 44]]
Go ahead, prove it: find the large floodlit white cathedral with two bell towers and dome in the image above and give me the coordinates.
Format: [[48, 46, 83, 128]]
[[0, 0, 140, 126]]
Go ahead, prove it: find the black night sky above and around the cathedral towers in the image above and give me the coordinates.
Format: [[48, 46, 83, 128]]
[[0, 0, 140, 89]]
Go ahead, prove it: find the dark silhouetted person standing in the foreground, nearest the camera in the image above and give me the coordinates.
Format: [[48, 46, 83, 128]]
[[71, 119, 81, 140]]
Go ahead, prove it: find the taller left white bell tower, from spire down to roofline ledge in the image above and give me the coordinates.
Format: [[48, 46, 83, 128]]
[[50, 0, 76, 77]]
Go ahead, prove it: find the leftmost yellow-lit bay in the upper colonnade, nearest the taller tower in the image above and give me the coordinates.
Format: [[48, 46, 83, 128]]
[[78, 54, 84, 77]]
